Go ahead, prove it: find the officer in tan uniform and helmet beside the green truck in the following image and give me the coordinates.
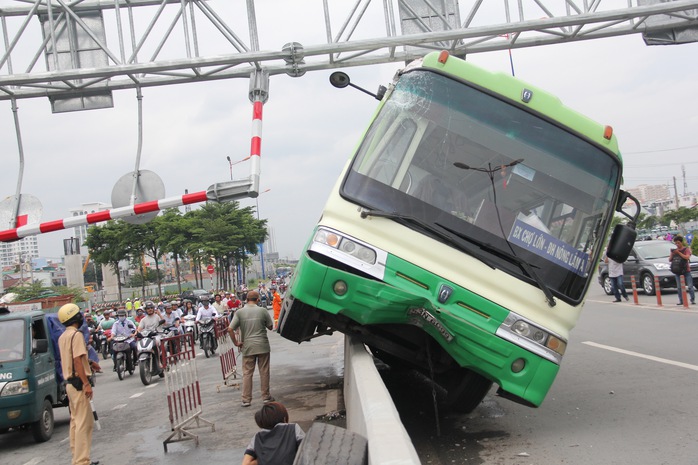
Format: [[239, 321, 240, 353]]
[[58, 304, 99, 465]]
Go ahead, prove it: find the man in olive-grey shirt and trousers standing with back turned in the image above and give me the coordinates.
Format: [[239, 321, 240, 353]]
[[228, 291, 274, 407]]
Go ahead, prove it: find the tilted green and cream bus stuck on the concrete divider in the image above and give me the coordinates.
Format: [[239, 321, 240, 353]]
[[279, 52, 636, 412]]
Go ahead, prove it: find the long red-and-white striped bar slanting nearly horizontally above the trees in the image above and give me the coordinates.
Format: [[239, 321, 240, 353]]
[[0, 191, 209, 242]]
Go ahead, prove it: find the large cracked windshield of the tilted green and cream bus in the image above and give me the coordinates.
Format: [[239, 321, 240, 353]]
[[341, 69, 621, 303]]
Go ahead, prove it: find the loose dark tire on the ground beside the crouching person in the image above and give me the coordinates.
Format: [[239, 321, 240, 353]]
[[293, 423, 368, 465]]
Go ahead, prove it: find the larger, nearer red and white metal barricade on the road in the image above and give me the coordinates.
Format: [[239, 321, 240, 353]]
[[160, 333, 216, 453]]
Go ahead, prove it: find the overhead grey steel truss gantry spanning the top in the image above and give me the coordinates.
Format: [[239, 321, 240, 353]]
[[0, 0, 698, 102]]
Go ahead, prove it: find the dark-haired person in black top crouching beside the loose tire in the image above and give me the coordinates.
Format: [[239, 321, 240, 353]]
[[242, 402, 305, 465]]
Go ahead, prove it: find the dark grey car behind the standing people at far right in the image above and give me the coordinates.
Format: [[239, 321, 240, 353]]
[[598, 240, 698, 295]]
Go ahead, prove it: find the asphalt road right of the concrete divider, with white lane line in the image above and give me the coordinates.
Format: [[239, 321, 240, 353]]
[[385, 286, 698, 465]]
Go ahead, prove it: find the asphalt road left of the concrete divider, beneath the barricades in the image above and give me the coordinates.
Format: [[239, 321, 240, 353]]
[[0, 320, 344, 465]]
